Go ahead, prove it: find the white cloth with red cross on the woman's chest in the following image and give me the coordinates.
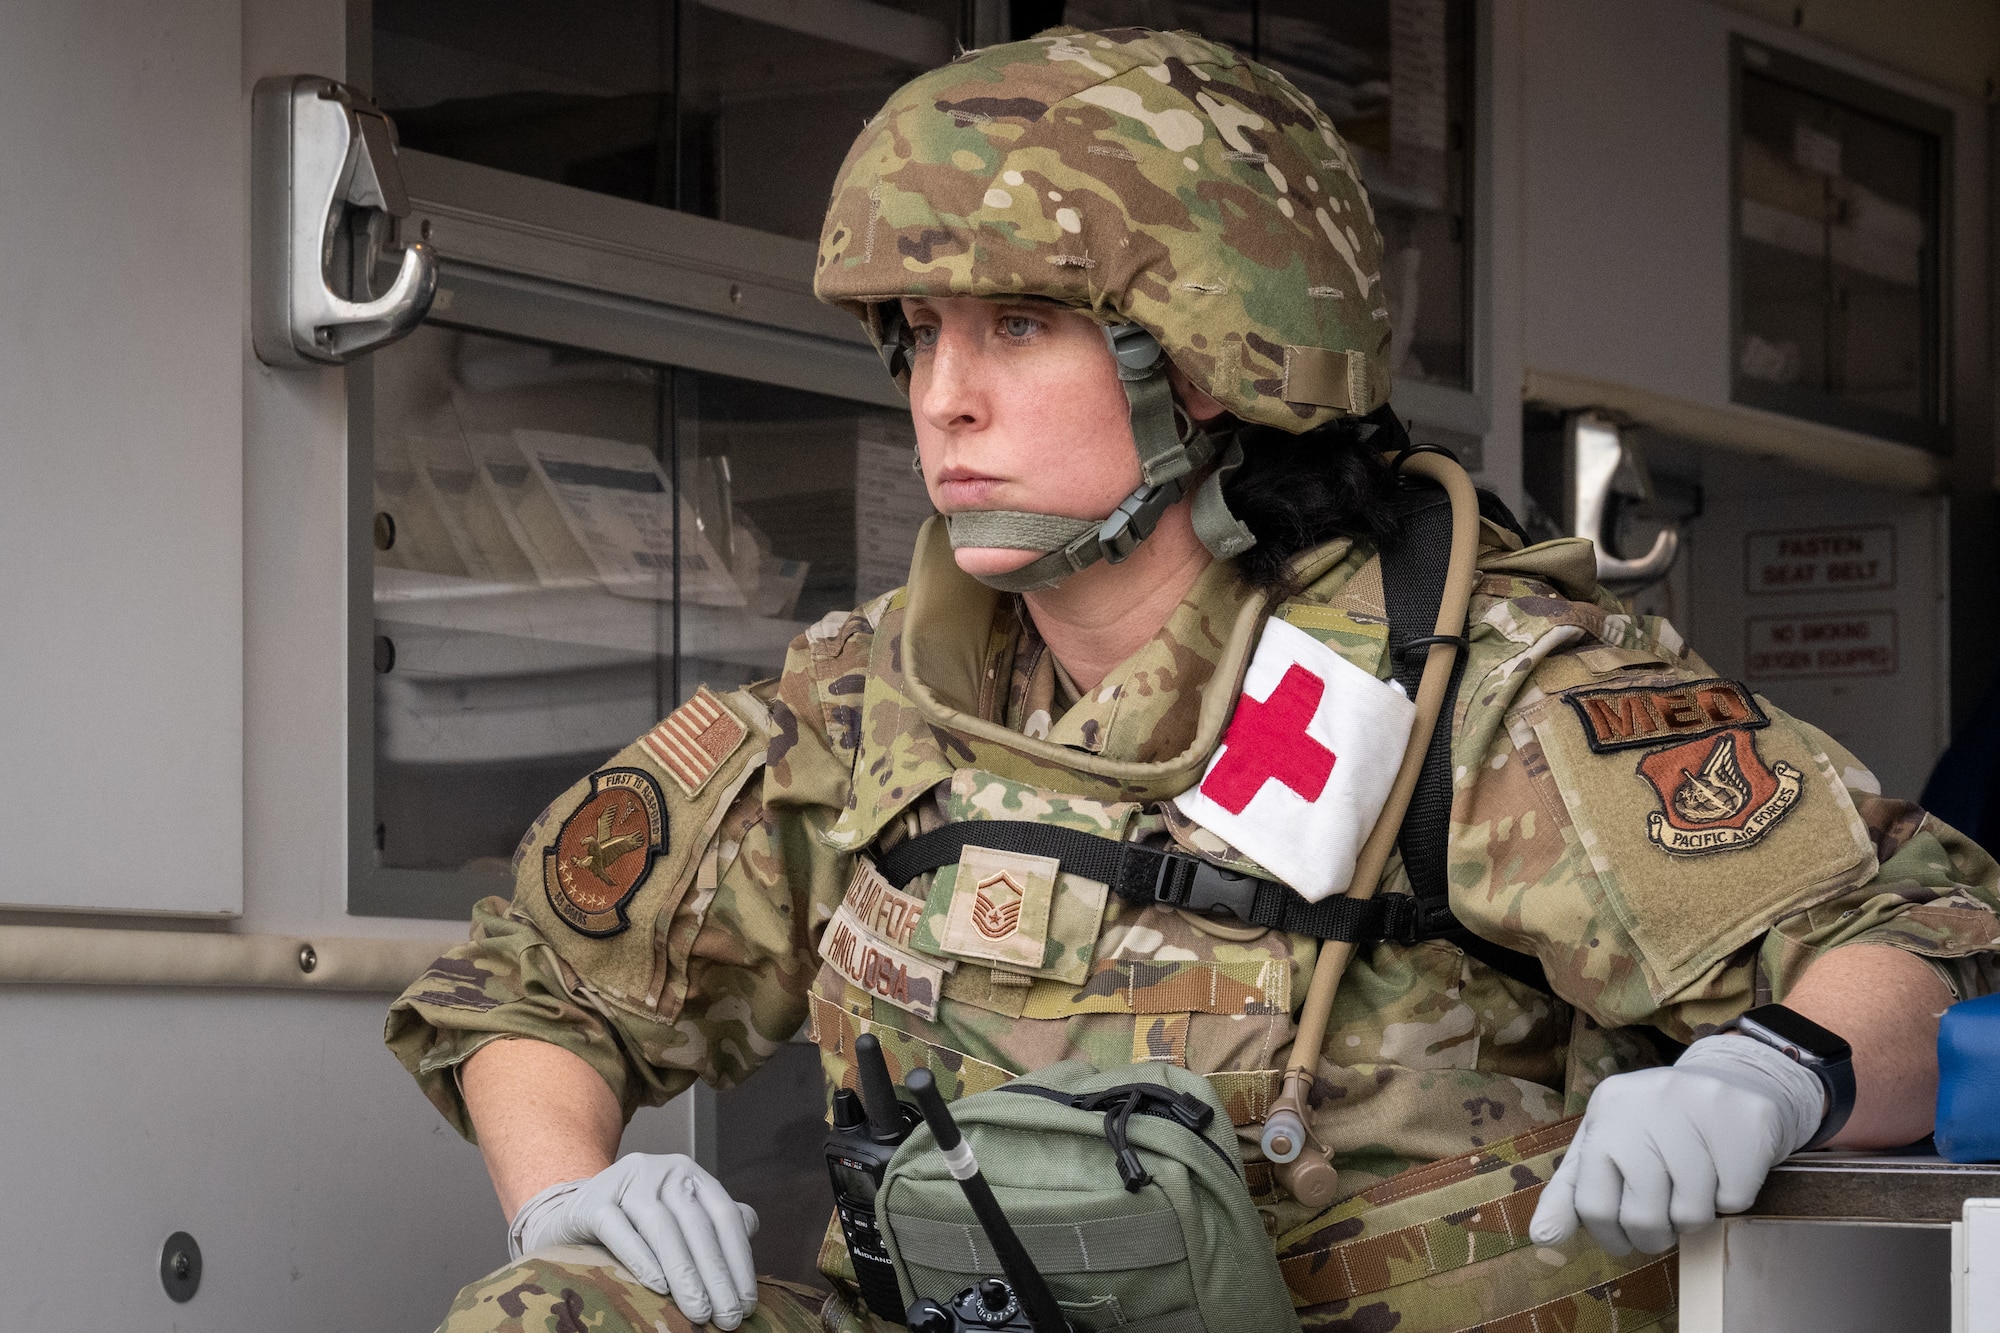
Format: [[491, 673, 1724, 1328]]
[[1174, 618, 1416, 903]]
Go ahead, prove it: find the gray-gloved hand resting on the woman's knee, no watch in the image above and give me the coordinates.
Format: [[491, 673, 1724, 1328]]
[[508, 1153, 758, 1329]]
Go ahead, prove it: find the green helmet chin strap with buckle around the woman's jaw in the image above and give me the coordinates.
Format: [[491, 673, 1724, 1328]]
[[946, 324, 1256, 592]]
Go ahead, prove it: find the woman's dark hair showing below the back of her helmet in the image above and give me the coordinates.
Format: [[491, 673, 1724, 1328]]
[[1222, 408, 1406, 590]]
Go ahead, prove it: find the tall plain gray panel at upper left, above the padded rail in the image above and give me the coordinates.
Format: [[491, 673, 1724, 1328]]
[[0, 0, 248, 913]]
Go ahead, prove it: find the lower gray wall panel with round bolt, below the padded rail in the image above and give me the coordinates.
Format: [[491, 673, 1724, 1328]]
[[0, 989, 704, 1333]]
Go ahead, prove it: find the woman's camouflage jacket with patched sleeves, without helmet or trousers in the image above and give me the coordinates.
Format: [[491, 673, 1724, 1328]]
[[388, 522, 2000, 1264]]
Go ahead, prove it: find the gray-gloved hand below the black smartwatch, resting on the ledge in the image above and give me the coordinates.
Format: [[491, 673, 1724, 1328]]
[[1528, 1033, 1826, 1255]]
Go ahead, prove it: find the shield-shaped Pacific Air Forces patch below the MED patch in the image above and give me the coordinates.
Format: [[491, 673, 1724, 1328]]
[[1638, 729, 1802, 857]]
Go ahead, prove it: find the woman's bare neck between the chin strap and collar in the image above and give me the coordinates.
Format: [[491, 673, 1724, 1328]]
[[1022, 496, 1214, 693]]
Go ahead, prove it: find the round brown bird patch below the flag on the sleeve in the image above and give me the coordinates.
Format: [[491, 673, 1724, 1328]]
[[542, 769, 666, 939]]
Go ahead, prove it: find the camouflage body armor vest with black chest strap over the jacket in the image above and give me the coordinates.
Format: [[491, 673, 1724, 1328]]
[[810, 510, 1672, 1331]]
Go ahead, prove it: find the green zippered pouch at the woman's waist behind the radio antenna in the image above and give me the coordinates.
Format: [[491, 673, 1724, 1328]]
[[876, 1061, 1298, 1333]]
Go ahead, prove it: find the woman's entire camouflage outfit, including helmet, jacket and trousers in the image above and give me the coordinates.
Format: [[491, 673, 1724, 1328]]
[[388, 30, 2000, 1333]]
